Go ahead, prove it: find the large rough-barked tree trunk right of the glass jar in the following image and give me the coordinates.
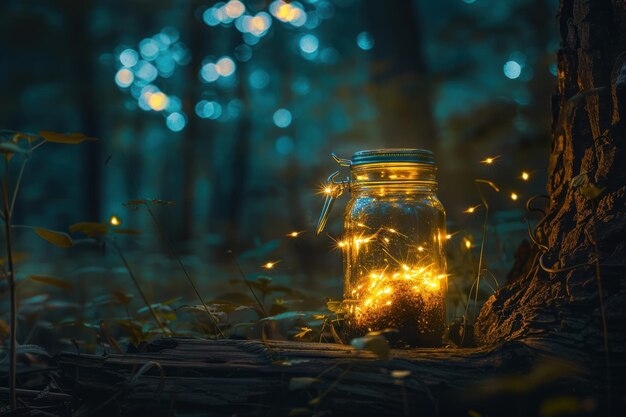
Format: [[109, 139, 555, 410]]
[[475, 0, 626, 394]]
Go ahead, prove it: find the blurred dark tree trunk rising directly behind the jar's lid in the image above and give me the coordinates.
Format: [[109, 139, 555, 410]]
[[365, 0, 437, 150]]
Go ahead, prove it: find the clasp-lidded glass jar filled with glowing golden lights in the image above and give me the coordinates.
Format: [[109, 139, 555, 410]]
[[318, 149, 447, 347]]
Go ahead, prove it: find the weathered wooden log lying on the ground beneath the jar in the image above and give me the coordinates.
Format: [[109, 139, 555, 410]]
[[51, 338, 595, 416]]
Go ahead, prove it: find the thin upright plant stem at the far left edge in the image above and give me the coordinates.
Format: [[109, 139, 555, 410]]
[[2, 156, 17, 410]]
